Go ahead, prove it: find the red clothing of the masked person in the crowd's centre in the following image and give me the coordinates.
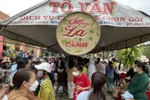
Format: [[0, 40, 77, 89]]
[[73, 73, 91, 100]]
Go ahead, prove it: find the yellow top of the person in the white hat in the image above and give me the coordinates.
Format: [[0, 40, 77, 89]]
[[38, 78, 56, 100]]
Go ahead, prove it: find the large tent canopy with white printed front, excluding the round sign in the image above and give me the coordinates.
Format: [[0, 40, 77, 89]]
[[0, 0, 150, 52]]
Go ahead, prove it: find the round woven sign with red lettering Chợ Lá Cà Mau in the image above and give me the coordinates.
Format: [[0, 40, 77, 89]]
[[56, 12, 100, 55]]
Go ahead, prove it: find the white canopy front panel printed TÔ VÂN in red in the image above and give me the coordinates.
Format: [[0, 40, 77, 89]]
[[10, 0, 150, 27]]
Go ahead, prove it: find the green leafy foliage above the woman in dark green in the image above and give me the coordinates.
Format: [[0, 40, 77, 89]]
[[117, 46, 142, 67]]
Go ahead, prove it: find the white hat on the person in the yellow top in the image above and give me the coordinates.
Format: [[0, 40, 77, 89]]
[[35, 62, 52, 73]]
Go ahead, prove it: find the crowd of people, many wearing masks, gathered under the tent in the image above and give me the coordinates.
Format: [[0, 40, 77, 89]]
[[0, 54, 149, 100]]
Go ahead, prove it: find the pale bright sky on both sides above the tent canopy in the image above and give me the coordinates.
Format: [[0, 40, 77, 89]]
[[0, 0, 150, 16]]
